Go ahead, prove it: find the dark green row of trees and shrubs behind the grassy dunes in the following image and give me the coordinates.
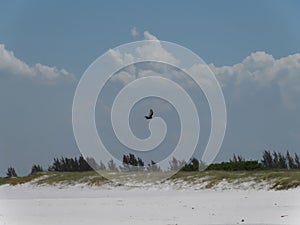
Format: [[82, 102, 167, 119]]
[[6, 150, 300, 177]]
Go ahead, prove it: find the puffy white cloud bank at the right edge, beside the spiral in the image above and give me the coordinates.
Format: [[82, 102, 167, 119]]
[[210, 52, 300, 107]]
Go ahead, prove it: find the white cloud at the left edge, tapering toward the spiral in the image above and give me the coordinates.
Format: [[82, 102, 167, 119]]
[[0, 44, 74, 81]]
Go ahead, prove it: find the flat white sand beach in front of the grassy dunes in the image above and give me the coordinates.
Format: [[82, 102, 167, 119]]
[[0, 184, 300, 225]]
